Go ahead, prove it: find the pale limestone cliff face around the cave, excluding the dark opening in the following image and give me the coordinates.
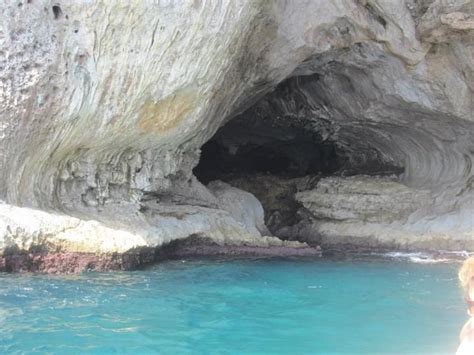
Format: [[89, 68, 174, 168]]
[[0, 0, 474, 258]]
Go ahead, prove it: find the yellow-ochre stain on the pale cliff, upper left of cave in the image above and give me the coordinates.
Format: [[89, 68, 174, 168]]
[[139, 87, 197, 133]]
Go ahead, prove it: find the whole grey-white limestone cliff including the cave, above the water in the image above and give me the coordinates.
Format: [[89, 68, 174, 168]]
[[0, 0, 474, 271]]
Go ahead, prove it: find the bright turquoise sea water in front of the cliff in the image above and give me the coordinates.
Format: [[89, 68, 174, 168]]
[[0, 259, 466, 354]]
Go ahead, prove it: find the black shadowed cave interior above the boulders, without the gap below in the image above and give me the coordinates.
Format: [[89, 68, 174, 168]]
[[194, 119, 344, 184]]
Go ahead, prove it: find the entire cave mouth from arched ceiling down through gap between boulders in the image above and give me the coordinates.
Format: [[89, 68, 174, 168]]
[[193, 75, 404, 241]]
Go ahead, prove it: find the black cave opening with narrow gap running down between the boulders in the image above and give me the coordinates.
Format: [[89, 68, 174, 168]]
[[194, 112, 346, 238]]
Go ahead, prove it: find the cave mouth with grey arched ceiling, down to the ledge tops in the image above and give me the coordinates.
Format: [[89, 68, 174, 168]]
[[193, 73, 405, 189]]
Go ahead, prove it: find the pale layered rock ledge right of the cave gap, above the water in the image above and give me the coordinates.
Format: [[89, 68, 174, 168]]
[[289, 176, 474, 251]]
